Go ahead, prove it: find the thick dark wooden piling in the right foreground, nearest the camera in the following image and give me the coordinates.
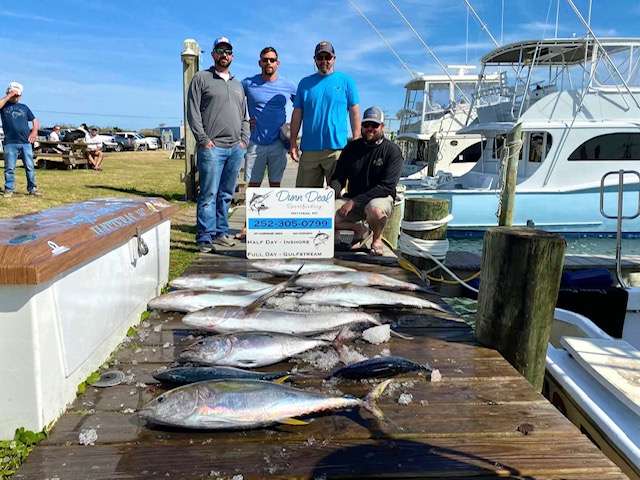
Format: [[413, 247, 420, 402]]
[[476, 227, 567, 391]]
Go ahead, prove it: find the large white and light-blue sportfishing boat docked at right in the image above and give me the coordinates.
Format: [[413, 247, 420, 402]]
[[401, 37, 640, 235]]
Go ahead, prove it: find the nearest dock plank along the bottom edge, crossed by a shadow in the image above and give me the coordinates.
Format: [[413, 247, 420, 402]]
[[14, 433, 625, 480]]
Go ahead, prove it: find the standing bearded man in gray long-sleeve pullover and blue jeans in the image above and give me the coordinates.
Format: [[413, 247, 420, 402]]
[[187, 37, 249, 253]]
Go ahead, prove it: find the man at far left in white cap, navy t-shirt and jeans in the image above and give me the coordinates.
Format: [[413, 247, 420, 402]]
[[0, 82, 42, 198]]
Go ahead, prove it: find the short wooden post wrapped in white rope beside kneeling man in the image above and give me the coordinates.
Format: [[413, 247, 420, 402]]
[[402, 198, 449, 270]]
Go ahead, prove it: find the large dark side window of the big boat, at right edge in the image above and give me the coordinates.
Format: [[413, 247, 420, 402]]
[[569, 133, 640, 161]]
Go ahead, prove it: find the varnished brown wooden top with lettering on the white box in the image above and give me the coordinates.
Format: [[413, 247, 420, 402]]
[[0, 198, 179, 285]]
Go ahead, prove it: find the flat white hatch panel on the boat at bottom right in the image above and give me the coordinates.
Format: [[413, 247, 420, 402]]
[[560, 337, 640, 415]]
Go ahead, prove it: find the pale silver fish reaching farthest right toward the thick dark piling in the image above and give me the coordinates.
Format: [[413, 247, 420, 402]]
[[298, 285, 449, 313]]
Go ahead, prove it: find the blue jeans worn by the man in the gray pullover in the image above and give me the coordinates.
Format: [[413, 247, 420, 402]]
[[196, 145, 244, 243]]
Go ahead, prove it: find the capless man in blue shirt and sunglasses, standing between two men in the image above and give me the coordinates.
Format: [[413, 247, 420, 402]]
[[235, 47, 296, 240]]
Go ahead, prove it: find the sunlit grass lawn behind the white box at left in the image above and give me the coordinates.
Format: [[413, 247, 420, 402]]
[[0, 150, 198, 278]]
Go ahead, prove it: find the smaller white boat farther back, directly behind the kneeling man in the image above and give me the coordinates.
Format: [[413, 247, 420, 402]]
[[396, 65, 500, 180]]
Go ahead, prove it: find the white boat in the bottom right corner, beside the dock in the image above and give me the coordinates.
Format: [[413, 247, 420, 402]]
[[543, 298, 640, 480]]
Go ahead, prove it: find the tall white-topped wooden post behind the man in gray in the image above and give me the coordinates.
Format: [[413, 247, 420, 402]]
[[180, 38, 201, 201]]
